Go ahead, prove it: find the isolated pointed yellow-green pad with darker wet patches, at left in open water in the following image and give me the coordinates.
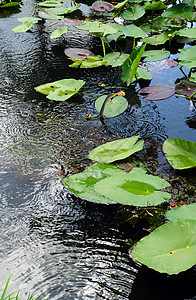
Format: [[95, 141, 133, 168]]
[[35, 79, 85, 101]]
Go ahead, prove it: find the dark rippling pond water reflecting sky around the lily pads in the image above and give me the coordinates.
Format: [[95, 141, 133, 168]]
[[0, 1, 196, 300]]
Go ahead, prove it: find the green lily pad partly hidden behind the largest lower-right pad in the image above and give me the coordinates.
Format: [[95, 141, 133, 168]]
[[166, 203, 196, 222]]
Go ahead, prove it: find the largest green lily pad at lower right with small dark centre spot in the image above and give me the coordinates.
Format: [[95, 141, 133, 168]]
[[131, 220, 196, 275]]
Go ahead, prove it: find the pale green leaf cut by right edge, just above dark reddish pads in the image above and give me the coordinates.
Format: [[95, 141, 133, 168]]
[[178, 46, 196, 69]]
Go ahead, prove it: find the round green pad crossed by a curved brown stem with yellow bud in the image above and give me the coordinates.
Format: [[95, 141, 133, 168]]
[[95, 95, 128, 118]]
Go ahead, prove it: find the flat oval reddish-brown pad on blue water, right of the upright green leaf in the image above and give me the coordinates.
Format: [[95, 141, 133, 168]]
[[138, 85, 175, 100]]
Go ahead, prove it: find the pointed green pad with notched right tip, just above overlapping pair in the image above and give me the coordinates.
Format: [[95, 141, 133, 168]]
[[88, 135, 144, 163]]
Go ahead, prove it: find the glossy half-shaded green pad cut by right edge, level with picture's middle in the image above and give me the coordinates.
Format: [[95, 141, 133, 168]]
[[163, 138, 196, 169]]
